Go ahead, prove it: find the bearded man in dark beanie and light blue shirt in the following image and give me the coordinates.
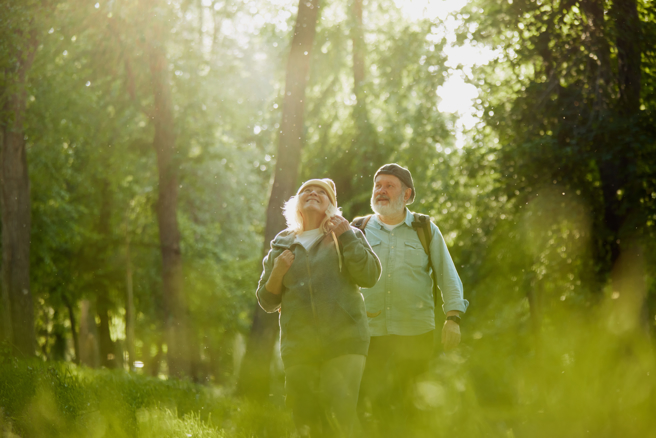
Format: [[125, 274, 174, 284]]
[[353, 164, 469, 430]]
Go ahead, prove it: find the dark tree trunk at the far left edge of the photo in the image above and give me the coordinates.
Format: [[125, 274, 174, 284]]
[[0, 33, 37, 356]]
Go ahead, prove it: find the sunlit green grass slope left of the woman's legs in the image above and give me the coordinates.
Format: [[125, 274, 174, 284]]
[[0, 358, 292, 438]]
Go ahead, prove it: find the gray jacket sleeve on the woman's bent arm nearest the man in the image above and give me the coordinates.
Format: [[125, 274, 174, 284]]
[[339, 227, 382, 288]]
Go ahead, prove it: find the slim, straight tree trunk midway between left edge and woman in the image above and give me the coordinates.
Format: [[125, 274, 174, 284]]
[[148, 18, 190, 377]]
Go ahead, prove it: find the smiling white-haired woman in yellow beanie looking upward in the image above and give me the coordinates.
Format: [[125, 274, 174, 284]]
[[257, 179, 381, 436]]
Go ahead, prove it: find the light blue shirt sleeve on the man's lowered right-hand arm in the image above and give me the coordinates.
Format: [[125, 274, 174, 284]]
[[430, 222, 469, 313]]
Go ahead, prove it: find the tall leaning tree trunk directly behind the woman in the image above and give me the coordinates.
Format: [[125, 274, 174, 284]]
[[237, 0, 320, 400]]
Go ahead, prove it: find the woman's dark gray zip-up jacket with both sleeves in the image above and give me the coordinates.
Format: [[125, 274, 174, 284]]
[[257, 227, 381, 367]]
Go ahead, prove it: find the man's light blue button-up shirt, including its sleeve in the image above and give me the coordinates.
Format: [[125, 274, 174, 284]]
[[362, 209, 469, 336]]
